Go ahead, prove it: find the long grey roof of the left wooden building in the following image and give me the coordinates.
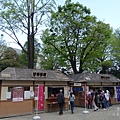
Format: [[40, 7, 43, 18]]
[[0, 67, 72, 81]]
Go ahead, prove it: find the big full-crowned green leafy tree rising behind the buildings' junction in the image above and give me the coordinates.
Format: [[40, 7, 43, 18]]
[[42, 0, 112, 74]]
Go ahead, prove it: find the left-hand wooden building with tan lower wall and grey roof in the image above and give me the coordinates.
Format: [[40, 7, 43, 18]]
[[0, 67, 72, 117]]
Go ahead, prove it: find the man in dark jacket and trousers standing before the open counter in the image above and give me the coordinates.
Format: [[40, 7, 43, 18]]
[[57, 89, 64, 115]]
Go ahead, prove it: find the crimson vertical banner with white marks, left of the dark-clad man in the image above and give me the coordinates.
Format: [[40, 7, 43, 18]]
[[38, 85, 44, 110]]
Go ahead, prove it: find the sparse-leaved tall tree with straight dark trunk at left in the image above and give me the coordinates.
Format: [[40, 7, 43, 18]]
[[0, 0, 55, 68]]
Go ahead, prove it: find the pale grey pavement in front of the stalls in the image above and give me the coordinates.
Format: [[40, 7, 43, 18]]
[[1, 104, 120, 120]]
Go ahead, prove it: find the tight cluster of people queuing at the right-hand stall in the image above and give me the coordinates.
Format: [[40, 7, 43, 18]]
[[87, 90, 110, 111]]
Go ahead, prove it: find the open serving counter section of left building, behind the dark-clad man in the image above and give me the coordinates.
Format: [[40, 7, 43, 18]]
[[45, 82, 69, 112]]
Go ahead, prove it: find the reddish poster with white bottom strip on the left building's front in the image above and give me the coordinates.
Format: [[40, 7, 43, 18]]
[[12, 87, 23, 102]]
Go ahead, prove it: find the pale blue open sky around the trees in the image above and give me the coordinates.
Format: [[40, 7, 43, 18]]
[[4, 0, 120, 49]]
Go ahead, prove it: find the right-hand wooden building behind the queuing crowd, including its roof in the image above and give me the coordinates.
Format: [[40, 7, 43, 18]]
[[69, 73, 120, 106]]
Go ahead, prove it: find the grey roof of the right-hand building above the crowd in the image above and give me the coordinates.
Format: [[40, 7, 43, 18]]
[[68, 73, 120, 82]]
